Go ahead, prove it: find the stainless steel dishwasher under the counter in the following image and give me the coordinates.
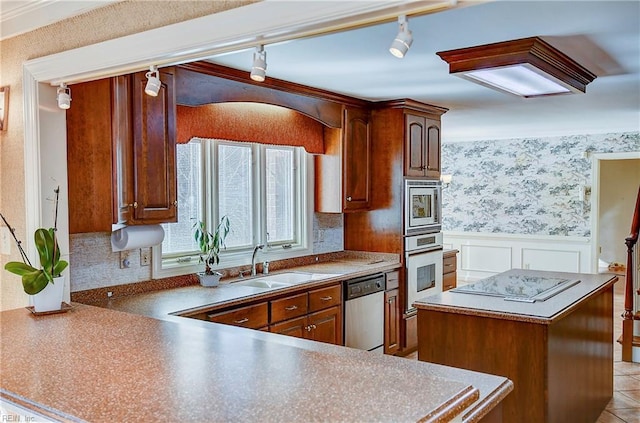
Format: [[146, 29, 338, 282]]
[[344, 274, 385, 353]]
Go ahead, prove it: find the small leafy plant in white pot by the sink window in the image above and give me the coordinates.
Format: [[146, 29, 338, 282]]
[[193, 216, 230, 287]]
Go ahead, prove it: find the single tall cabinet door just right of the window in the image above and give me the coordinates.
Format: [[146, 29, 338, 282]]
[[342, 108, 371, 211]]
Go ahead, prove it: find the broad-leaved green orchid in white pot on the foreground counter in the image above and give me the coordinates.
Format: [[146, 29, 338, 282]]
[[0, 187, 69, 312]]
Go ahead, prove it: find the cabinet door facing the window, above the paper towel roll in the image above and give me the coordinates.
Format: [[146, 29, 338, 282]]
[[131, 70, 178, 224]]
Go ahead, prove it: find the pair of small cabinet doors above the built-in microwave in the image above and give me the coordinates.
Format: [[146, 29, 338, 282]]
[[405, 113, 440, 178]]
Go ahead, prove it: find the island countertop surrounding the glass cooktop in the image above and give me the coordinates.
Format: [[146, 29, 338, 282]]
[[414, 269, 618, 324]]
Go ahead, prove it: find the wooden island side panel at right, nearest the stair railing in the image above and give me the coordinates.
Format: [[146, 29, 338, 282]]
[[547, 285, 613, 423]]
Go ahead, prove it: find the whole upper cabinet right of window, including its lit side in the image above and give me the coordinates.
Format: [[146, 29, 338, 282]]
[[315, 107, 371, 213]]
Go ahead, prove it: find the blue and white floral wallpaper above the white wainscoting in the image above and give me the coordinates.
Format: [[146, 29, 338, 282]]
[[442, 132, 640, 237]]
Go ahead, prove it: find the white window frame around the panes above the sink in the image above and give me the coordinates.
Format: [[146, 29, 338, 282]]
[[151, 138, 314, 279]]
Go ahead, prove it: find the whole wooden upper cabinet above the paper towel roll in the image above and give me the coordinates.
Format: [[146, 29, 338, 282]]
[[67, 68, 177, 233]]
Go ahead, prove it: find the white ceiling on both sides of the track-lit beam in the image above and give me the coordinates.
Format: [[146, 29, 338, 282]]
[[0, 0, 640, 141]]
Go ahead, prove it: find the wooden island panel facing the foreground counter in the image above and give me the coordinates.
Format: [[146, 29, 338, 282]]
[[418, 309, 547, 423]]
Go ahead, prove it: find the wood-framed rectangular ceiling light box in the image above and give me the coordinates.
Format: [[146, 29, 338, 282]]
[[436, 37, 596, 98]]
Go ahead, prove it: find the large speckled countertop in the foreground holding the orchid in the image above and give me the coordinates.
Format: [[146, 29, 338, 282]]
[[0, 304, 513, 422]]
